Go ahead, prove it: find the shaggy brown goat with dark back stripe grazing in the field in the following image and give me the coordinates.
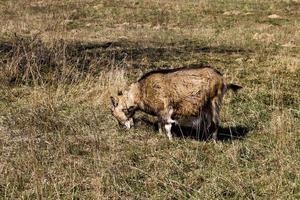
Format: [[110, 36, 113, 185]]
[[111, 67, 241, 140]]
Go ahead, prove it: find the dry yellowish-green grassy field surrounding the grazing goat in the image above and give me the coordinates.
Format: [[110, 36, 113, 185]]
[[0, 0, 300, 199]]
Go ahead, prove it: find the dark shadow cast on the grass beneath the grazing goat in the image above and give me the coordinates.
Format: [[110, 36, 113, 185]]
[[136, 118, 250, 141]]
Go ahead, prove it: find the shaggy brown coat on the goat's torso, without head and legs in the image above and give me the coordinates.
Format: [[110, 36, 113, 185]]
[[138, 67, 224, 116]]
